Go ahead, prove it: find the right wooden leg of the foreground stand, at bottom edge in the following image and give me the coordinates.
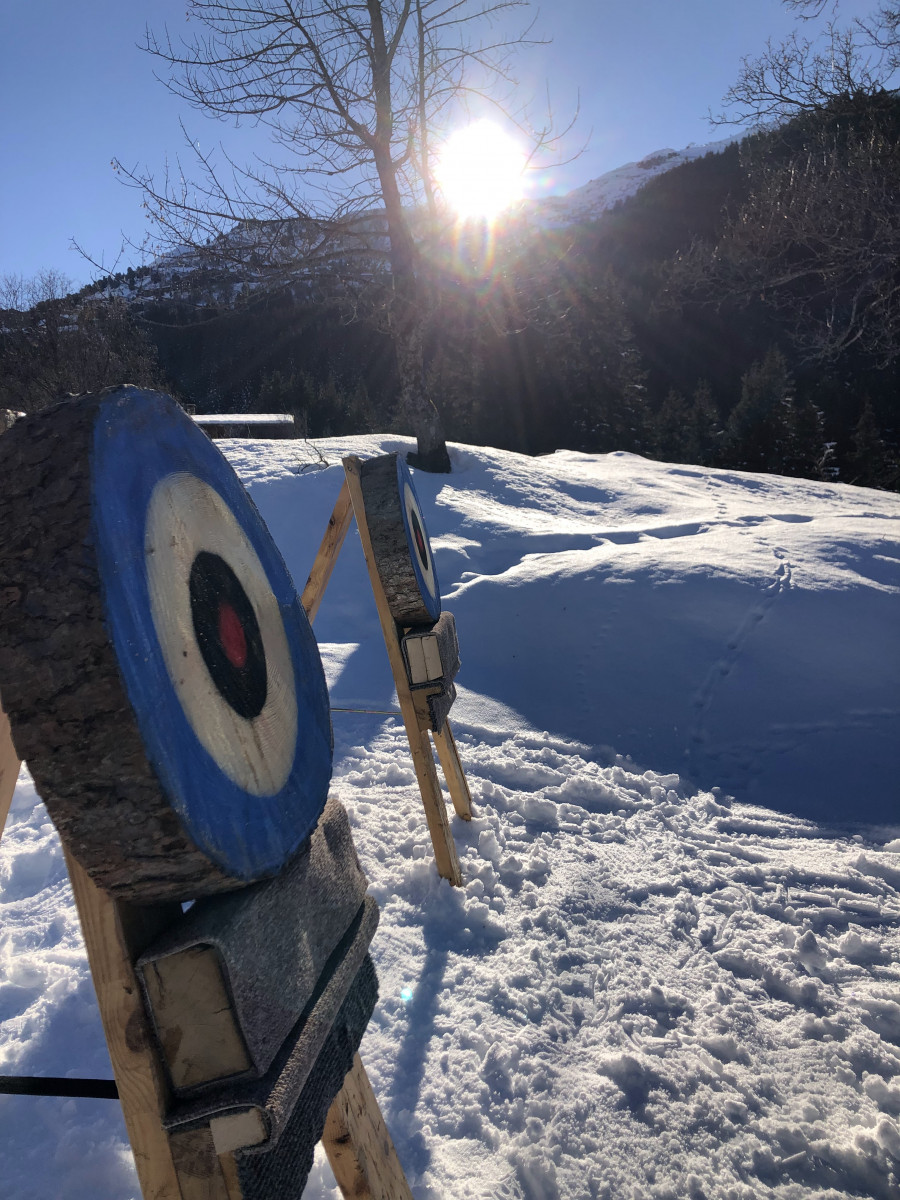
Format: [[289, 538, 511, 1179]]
[[322, 1055, 413, 1200]]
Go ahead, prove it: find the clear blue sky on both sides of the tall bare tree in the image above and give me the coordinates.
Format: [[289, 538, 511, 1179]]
[[0, 0, 872, 283]]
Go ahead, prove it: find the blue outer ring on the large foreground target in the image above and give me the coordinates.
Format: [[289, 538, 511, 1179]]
[[91, 390, 332, 883]]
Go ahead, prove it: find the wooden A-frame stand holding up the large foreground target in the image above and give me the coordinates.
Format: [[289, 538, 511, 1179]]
[[0, 708, 413, 1200]]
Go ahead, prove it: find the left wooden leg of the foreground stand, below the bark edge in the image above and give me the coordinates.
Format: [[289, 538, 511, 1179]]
[[66, 853, 234, 1200]]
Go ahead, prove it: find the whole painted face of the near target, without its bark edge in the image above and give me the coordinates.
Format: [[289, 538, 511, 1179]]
[[91, 391, 332, 883]]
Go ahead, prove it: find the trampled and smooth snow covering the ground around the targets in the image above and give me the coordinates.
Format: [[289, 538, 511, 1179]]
[[0, 437, 900, 1200]]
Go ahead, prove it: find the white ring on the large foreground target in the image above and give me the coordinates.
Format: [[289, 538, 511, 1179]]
[[144, 472, 298, 796]]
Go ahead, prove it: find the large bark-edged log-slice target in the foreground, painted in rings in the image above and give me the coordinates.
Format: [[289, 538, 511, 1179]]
[[0, 388, 331, 901]]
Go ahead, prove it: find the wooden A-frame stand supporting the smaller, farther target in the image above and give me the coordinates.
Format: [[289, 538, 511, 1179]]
[[300, 455, 472, 887]]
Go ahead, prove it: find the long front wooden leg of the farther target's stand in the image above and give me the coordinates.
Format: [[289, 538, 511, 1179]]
[[343, 455, 462, 887]]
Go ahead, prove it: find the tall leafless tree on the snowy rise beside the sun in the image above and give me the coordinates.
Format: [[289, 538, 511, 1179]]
[[120, 0, 548, 470]]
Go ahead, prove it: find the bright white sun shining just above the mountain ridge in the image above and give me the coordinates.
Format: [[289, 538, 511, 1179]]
[[436, 120, 526, 221]]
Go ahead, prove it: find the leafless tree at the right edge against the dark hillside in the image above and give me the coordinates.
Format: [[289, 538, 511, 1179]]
[[672, 0, 900, 366]]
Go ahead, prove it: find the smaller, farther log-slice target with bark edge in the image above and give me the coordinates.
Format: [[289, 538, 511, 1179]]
[[360, 454, 440, 625]]
